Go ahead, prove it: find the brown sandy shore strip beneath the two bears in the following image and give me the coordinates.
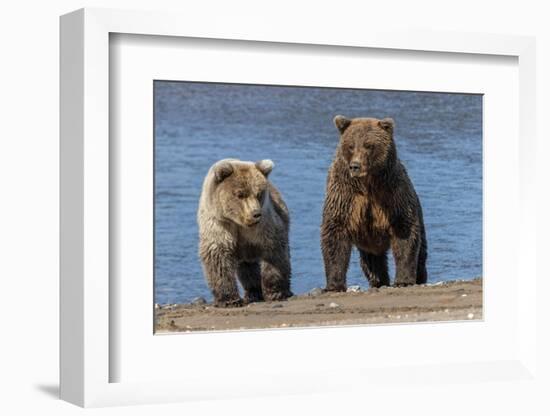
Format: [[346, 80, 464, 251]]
[[155, 279, 482, 333]]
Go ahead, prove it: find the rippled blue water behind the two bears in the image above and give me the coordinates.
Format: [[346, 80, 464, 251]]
[[154, 81, 482, 304]]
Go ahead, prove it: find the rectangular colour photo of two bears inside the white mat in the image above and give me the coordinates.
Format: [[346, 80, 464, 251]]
[[153, 80, 483, 333]]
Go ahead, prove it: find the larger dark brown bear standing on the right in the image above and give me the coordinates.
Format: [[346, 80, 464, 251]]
[[321, 116, 428, 291]]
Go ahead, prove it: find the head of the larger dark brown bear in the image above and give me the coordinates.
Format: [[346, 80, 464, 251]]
[[334, 116, 396, 177]]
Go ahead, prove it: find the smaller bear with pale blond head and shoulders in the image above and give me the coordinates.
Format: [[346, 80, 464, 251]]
[[197, 159, 292, 307]]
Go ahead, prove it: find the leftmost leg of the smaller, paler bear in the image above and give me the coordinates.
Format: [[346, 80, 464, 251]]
[[200, 247, 243, 307]]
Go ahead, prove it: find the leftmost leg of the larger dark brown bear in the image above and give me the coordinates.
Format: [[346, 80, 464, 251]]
[[321, 223, 351, 292]]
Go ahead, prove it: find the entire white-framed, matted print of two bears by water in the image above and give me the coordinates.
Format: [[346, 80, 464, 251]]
[[61, 9, 537, 406]]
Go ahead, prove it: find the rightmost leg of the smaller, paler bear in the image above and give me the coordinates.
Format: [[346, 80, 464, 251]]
[[261, 254, 292, 301]]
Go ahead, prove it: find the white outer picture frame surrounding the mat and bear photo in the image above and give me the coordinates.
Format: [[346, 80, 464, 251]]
[[60, 9, 537, 407]]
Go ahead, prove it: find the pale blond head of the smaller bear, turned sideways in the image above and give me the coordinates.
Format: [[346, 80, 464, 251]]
[[213, 160, 273, 227]]
